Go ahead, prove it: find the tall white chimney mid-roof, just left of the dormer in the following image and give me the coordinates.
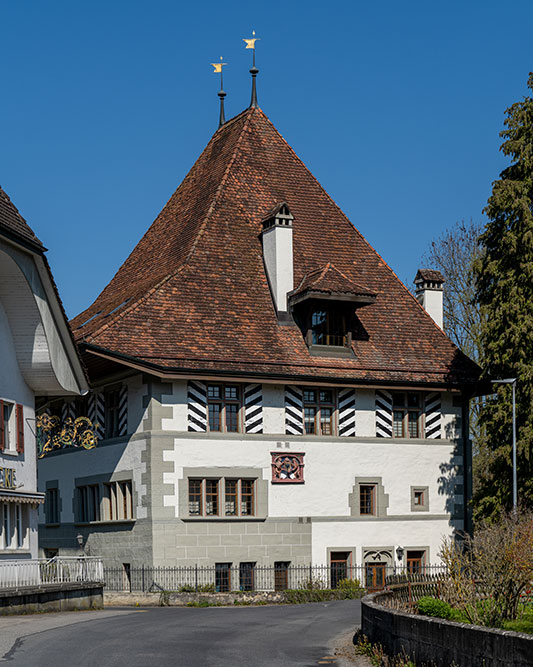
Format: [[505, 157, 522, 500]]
[[262, 202, 294, 318]]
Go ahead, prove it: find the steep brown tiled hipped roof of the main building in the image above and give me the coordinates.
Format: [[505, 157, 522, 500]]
[[72, 108, 477, 384]]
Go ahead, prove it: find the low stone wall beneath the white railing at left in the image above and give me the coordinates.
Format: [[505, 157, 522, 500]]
[[0, 582, 104, 616]]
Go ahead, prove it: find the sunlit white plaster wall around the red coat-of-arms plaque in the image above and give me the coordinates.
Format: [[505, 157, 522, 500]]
[[163, 435, 456, 517]]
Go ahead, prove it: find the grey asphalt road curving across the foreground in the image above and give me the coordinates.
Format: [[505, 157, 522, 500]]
[[0, 600, 361, 667]]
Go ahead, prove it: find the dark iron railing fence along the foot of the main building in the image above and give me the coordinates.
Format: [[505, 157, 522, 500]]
[[104, 563, 445, 593]]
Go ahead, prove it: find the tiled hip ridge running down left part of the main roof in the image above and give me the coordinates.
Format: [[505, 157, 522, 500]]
[[83, 109, 255, 340]]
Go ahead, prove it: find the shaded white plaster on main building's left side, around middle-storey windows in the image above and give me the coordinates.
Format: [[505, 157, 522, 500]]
[[39, 439, 148, 523]]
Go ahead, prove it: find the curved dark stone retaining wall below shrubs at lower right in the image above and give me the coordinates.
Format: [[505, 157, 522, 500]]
[[361, 593, 533, 667]]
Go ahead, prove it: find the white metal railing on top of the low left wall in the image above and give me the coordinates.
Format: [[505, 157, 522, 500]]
[[0, 556, 104, 588]]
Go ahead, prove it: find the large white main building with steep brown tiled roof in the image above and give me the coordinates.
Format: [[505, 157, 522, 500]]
[[37, 83, 478, 587]]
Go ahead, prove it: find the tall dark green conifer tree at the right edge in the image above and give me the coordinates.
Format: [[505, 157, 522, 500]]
[[474, 73, 533, 518]]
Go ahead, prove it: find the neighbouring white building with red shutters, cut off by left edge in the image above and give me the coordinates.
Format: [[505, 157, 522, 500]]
[[0, 188, 88, 560]]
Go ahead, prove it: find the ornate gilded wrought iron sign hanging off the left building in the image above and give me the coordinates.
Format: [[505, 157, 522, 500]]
[[37, 413, 98, 459]]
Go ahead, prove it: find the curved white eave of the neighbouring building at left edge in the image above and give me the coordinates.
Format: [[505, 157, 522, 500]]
[[0, 238, 88, 395]]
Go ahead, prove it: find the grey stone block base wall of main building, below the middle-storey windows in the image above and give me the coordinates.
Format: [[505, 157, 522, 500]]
[[39, 517, 311, 567]]
